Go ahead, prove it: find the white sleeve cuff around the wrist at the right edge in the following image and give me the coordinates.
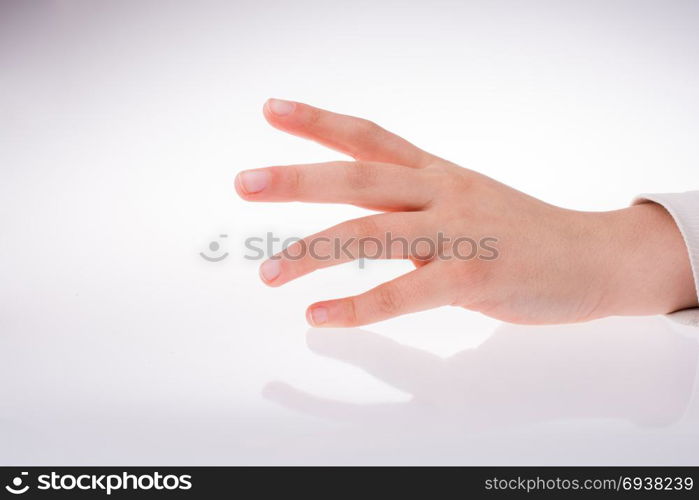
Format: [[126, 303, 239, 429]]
[[633, 191, 699, 327]]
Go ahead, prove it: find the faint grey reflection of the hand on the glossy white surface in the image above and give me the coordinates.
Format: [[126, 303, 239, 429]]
[[264, 317, 699, 429]]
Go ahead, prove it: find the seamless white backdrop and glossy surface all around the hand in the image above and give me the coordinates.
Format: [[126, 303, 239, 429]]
[[0, 0, 699, 465]]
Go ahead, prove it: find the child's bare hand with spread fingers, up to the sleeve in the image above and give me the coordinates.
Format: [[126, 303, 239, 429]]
[[235, 99, 697, 327]]
